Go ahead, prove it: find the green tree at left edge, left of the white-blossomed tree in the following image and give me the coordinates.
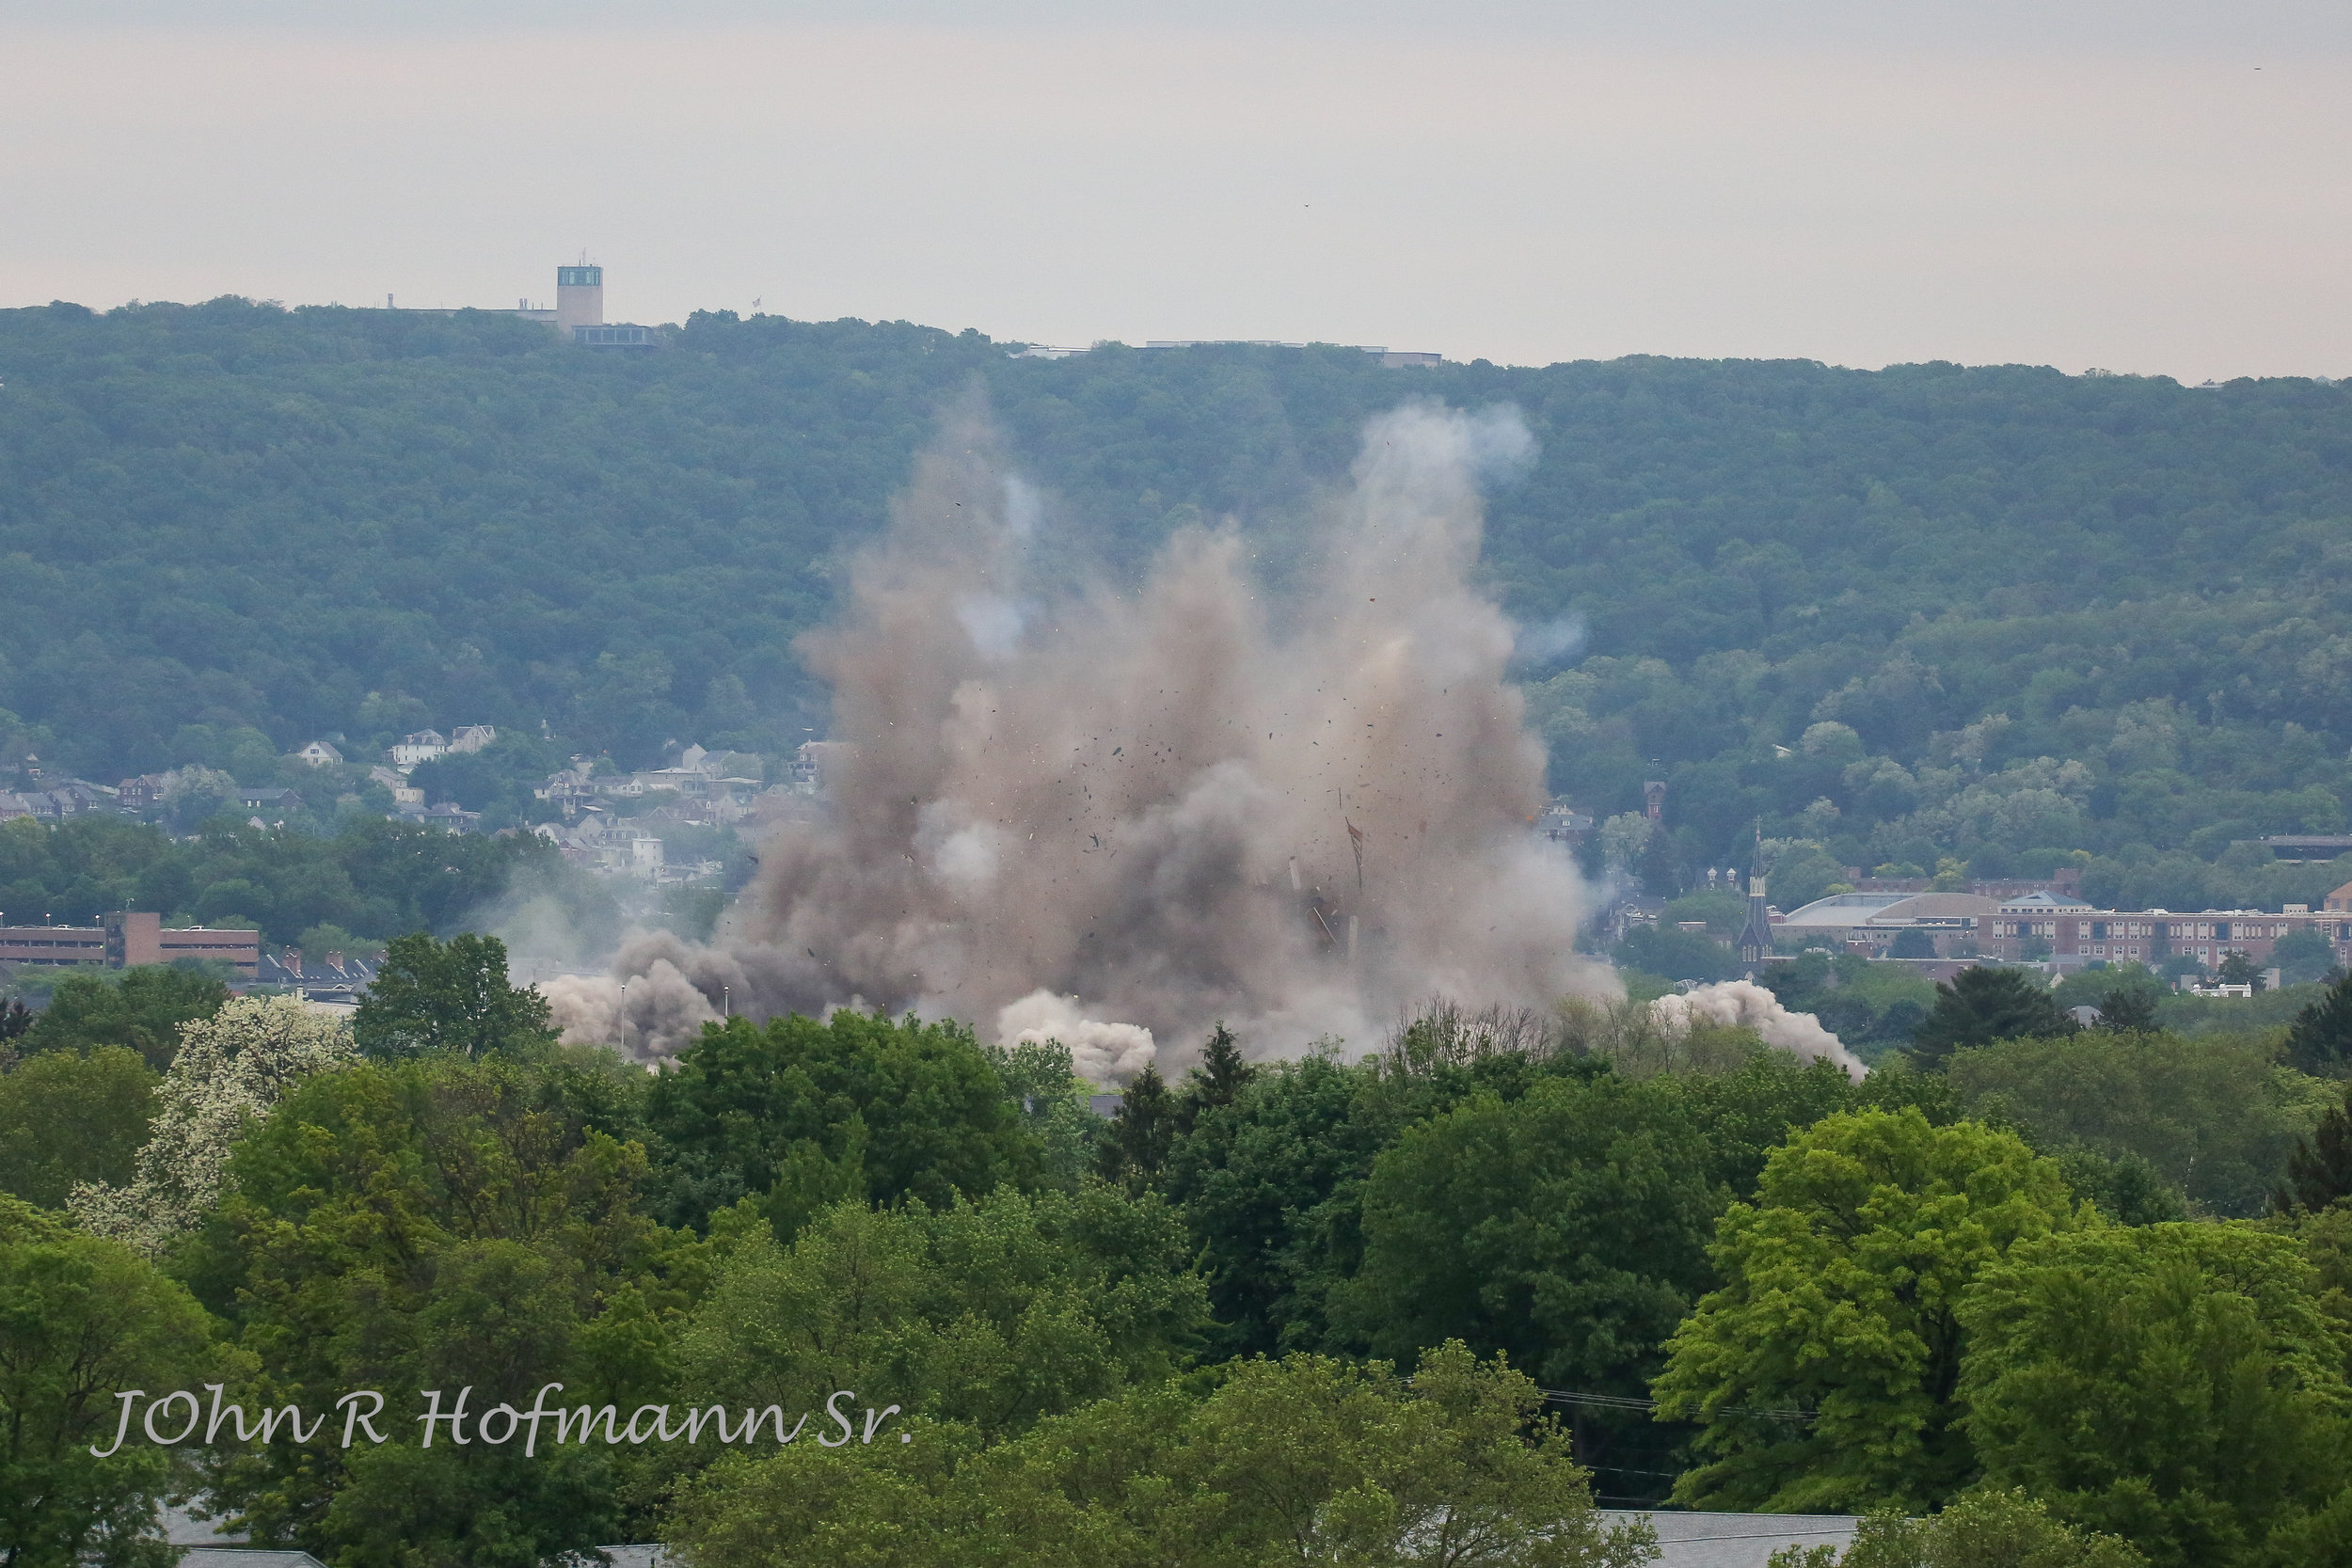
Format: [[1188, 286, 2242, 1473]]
[[0, 1046, 158, 1209]]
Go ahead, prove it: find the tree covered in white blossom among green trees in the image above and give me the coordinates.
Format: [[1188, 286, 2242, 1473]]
[[66, 997, 358, 1258]]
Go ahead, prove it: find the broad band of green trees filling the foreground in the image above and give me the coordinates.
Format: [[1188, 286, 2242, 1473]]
[[0, 936, 2352, 1568]]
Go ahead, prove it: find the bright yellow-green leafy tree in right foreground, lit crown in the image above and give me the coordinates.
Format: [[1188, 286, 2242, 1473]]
[[1654, 1110, 2077, 1512]]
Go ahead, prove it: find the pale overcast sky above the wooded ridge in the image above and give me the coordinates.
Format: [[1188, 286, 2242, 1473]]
[[0, 0, 2352, 381]]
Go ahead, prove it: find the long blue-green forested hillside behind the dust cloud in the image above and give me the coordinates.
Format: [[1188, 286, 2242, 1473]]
[[0, 301, 2352, 903]]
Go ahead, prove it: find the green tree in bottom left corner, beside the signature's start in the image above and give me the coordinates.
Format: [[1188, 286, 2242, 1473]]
[[0, 1196, 212, 1568]]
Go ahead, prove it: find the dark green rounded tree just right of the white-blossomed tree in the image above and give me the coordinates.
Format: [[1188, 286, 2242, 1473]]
[[351, 931, 555, 1058]]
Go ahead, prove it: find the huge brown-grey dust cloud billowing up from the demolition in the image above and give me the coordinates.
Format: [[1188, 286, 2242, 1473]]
[[550, 406, 1599, 1079]]
